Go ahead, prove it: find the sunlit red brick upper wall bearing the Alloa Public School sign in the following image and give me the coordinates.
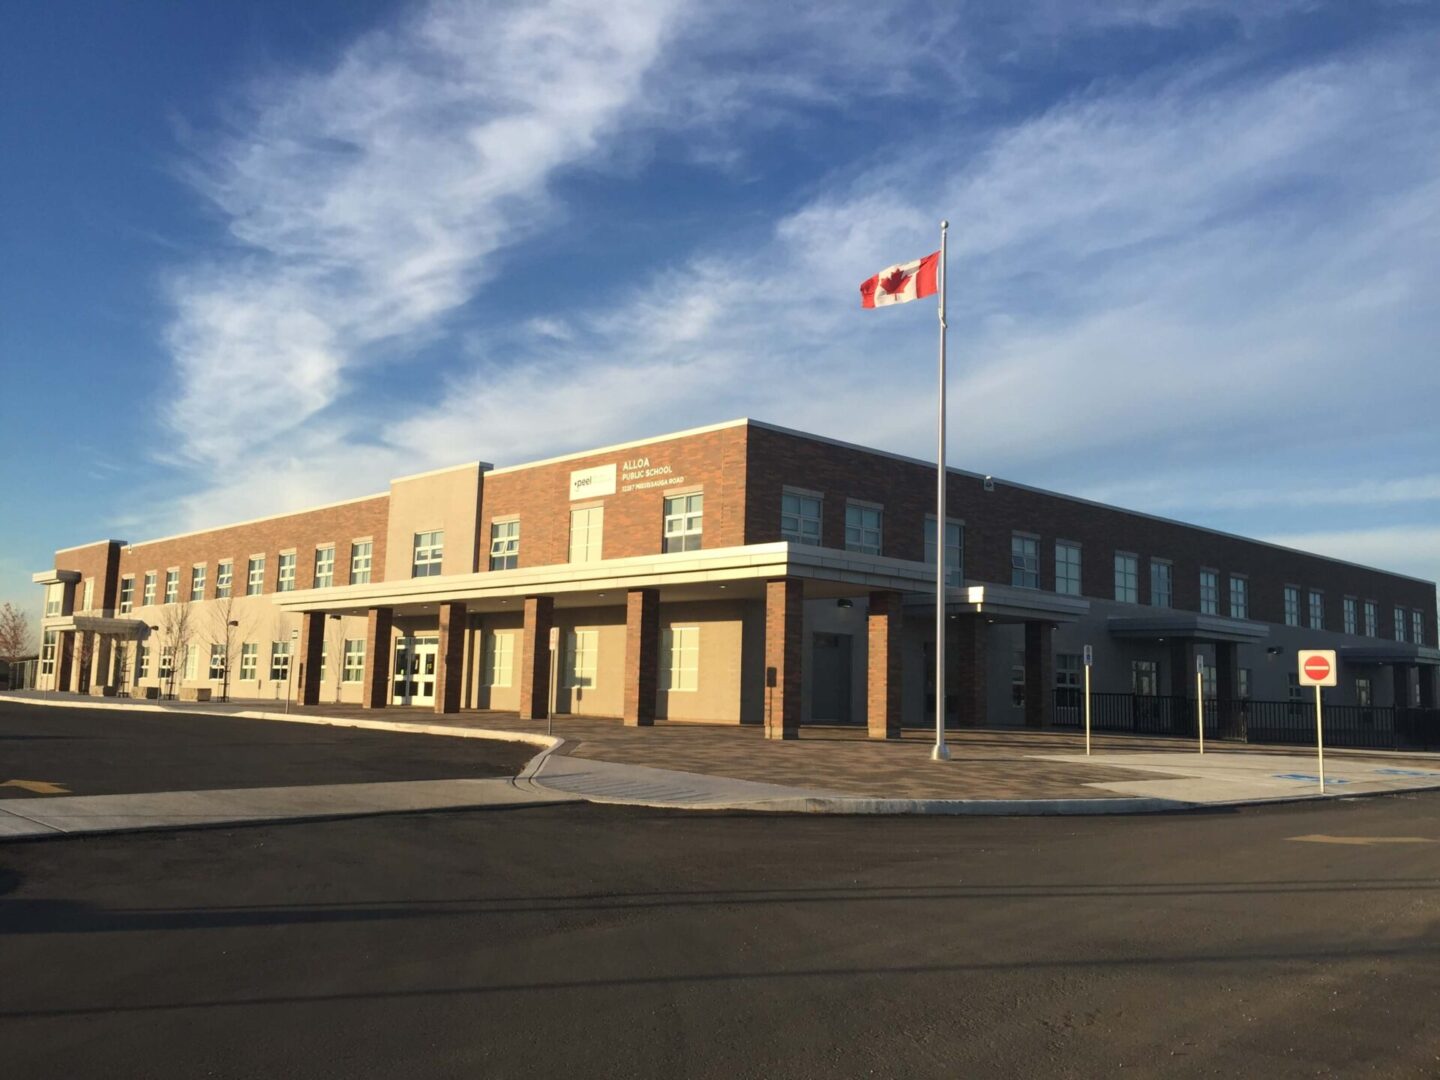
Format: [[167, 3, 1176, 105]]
[[480, 426, 746, 570]]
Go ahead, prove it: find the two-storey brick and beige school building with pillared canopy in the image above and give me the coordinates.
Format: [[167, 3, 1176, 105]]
[[25, 419, 1440, 737]]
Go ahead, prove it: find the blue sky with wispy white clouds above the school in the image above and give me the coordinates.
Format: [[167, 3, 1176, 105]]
[[0, 0, 1440, 608]]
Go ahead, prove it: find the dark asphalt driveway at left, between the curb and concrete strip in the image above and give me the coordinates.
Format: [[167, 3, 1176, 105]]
[[0, 701, 536, 798]]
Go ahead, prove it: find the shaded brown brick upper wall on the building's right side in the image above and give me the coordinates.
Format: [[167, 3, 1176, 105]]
[[746, 428, 1436, 633]]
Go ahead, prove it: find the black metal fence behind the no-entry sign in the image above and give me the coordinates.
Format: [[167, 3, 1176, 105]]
[[1053, 688, 1440, 750]]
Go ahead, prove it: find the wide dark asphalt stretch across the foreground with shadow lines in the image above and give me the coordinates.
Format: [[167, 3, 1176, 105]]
[[0, 795, 1440, 1080]]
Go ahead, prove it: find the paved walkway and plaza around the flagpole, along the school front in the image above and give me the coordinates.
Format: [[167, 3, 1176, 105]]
[[0, 694, 1440, 814]]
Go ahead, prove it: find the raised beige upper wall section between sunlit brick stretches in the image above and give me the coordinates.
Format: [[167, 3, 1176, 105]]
[[383, 465, 481, 582]]
